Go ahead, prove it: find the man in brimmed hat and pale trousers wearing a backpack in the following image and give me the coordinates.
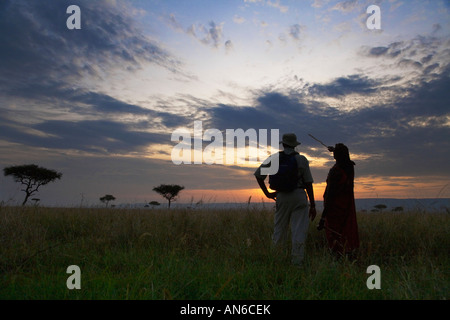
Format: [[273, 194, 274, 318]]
[[255, 133, 316, 265]]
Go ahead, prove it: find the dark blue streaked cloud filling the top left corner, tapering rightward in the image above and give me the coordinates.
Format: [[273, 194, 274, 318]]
[[0, 0, 183, 85]]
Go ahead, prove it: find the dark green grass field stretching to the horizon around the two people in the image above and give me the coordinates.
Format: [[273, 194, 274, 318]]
[[0, 207, 450, 300]]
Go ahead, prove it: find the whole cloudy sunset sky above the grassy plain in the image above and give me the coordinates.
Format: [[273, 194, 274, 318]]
[[0, 0, 450, 206]]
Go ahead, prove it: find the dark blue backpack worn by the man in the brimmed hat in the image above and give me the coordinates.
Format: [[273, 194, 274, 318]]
[[269, 151, 298, 192]]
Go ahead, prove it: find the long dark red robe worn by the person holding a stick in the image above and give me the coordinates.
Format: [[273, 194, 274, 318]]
[[323, 163, 359, 254]]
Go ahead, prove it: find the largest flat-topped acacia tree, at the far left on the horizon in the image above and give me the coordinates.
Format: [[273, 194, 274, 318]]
[[3, 164, 62, 206]]
